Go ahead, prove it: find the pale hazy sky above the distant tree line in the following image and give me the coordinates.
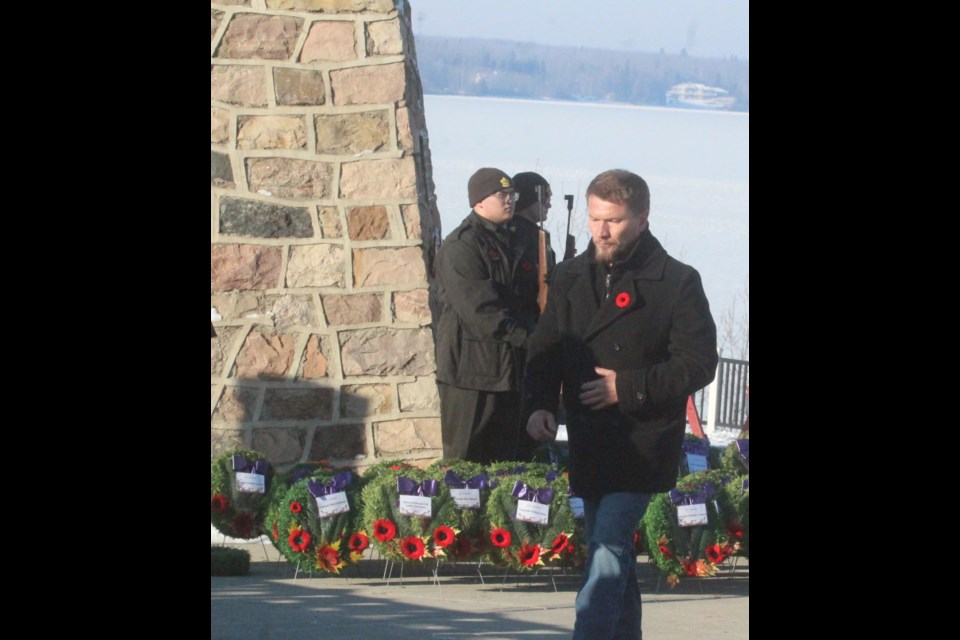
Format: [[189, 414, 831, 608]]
[[409, 0, 750, 60]]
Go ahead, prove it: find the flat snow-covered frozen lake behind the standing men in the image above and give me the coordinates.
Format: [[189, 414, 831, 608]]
[[424, 95, 750, 319]]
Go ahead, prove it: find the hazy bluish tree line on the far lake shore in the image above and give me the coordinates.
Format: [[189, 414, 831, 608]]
[[416, 36, 750, 111]]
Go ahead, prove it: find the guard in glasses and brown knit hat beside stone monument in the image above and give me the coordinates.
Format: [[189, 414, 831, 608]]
[[435, 167, 535, 464]]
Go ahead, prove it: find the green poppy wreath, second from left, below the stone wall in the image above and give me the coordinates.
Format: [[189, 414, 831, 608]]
[[276, 469, 369, 574]]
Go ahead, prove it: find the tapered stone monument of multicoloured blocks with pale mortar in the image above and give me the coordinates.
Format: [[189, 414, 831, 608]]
[[210, 0, 442, 469]]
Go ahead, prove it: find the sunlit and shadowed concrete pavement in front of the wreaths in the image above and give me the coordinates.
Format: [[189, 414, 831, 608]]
[[210, 540, 750, 640]]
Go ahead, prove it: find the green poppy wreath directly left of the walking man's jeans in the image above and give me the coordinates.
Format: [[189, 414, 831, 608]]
[[485, 470, 586, 571]]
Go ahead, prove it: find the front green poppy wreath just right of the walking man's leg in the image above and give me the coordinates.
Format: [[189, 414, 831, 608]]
[[642, 470, 736, 587]]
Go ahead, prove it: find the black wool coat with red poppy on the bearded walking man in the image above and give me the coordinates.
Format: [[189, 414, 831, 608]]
[[524, 230, 719, 497]]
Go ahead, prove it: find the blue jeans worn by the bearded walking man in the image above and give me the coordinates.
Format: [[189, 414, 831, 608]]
[[573, 492, 651, 640]]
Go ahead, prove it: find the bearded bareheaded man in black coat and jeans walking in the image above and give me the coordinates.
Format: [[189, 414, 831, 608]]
[[524, 169, 719, 640]]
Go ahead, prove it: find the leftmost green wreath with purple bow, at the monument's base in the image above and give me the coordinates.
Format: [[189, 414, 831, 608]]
[[210, 449, 276, 540]]
